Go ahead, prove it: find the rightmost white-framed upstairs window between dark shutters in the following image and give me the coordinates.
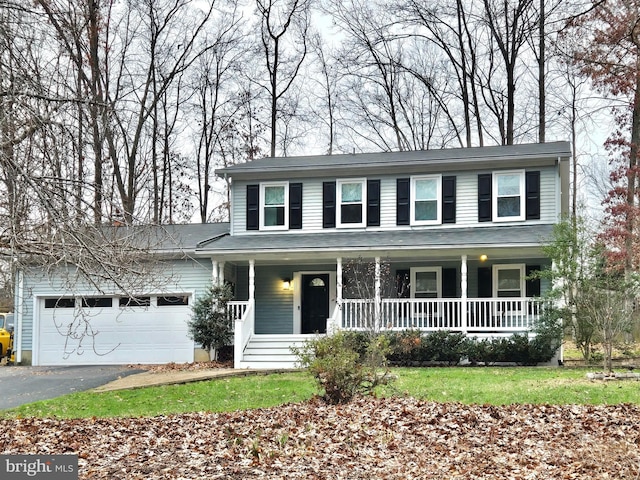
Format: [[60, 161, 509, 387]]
[[493, 170, 525, 222]]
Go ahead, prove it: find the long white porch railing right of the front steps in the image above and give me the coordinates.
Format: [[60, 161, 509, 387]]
[[339, 298, 542, 332]]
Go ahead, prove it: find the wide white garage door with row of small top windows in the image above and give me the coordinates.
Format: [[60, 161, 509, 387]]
[[34, 295, 194, 365]]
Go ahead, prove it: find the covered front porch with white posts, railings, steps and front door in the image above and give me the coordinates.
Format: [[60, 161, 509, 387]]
[[213, 250, 547, 368]]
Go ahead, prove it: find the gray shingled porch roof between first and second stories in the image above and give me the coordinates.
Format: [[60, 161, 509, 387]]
[[198, 225, 553, 254]]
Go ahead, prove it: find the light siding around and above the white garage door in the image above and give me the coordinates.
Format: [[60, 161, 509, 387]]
[[16, 259, 211, 350]]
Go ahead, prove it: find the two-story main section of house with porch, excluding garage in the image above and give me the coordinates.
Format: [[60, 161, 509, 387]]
[[209, 142, 571, 367]]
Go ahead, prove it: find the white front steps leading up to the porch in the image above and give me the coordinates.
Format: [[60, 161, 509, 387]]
[[240, 334, 315, 370]]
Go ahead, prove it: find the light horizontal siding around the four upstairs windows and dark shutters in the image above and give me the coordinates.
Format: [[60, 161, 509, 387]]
[[232, 167, 558, 235]]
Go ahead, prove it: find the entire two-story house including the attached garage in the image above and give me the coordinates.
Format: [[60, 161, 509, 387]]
[[10, 142, 571, 368]]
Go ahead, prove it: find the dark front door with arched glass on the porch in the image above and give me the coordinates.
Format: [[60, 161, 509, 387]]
[[302, 273, 329, 333]]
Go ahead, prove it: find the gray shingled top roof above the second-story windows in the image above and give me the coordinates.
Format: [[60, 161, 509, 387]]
[[216, 142, 571, 178]]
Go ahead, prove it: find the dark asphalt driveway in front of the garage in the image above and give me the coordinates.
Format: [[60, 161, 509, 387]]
[[0, 365, 143, 410]]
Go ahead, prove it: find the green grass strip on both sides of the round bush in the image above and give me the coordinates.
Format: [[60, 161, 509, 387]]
[[0, 367, 640, 418]]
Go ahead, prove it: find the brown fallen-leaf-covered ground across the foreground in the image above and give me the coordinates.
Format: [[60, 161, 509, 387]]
[[0, 398, 640, 480]]
